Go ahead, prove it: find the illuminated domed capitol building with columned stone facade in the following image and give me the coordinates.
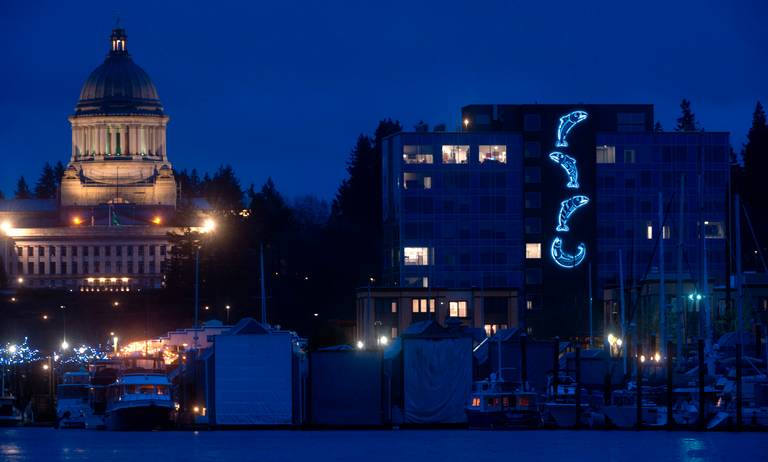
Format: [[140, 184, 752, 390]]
[[0, 28, 204, 291]]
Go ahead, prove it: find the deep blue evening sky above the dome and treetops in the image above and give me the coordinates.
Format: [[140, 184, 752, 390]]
[[0, 0, 768, 198]]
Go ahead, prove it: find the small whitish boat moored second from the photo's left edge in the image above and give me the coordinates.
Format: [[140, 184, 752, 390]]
[[56, 371, 93, 428]]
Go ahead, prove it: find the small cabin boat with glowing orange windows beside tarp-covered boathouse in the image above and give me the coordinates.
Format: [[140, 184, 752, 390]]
[[465, 374, 541, 429]]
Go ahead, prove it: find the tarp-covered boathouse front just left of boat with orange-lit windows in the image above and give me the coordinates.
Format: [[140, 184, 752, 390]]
[[402, 336, 472, 424]]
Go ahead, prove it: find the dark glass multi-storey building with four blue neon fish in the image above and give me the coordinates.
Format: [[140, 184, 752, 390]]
[[358, 104, 730, 337]]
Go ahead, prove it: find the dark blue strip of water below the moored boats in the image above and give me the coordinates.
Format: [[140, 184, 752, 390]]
[[0, 428, 768, 462]]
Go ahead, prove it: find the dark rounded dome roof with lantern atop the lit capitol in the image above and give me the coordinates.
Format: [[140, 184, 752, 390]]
[[75, 28, 163, 116]]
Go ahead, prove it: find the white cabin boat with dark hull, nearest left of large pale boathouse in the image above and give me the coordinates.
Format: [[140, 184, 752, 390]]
[[104, 371, 175, 430]]
